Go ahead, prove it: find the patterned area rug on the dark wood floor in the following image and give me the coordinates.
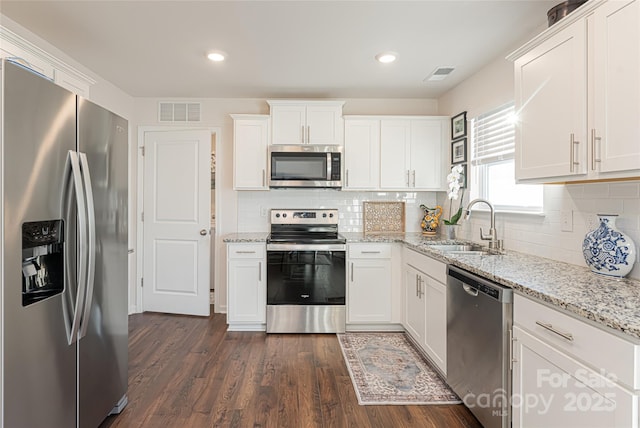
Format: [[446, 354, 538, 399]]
[[338, 333, 461, 405]]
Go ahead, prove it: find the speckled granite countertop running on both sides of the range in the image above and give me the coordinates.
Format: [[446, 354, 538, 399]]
[[223, 233, 640, 343]]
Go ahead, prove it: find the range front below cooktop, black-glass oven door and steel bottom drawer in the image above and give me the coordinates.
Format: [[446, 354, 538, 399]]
[[267, 245, 346, 333]]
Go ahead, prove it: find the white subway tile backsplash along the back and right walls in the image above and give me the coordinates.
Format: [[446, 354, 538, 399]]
[[238, 182, 640, 279]]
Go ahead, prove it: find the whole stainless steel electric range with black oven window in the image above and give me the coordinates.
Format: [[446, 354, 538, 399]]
[[267, 209, 346, 333]]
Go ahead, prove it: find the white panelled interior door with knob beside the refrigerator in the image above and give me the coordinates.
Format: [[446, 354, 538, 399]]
[[142, 130, 211, 316]]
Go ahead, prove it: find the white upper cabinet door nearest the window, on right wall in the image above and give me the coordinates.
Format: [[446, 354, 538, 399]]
[[515, 17, 587, 180]]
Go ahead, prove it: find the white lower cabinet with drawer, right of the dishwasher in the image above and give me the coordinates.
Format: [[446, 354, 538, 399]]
[[512, 295, 640, 428]]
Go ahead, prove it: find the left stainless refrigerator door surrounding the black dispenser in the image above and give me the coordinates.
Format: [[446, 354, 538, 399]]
[[0, 62, 77, 428]]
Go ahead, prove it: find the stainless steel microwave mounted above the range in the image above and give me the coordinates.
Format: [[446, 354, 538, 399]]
[[268, 145, 342, 188]]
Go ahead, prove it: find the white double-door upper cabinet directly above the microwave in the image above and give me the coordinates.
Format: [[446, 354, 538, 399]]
[[267, 100, 344, 145]]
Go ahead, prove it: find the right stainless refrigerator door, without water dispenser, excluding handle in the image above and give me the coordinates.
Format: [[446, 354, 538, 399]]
[[78, 98, 128, 428]]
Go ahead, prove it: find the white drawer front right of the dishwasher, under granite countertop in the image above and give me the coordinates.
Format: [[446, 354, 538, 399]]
[[513, 294, 640, 389]]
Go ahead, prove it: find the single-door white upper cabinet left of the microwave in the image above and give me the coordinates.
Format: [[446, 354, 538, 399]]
[[231, 114, 269, 190]]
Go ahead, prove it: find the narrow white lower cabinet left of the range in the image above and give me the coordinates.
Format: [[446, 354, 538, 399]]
[[227, 243, 267, 331]]
